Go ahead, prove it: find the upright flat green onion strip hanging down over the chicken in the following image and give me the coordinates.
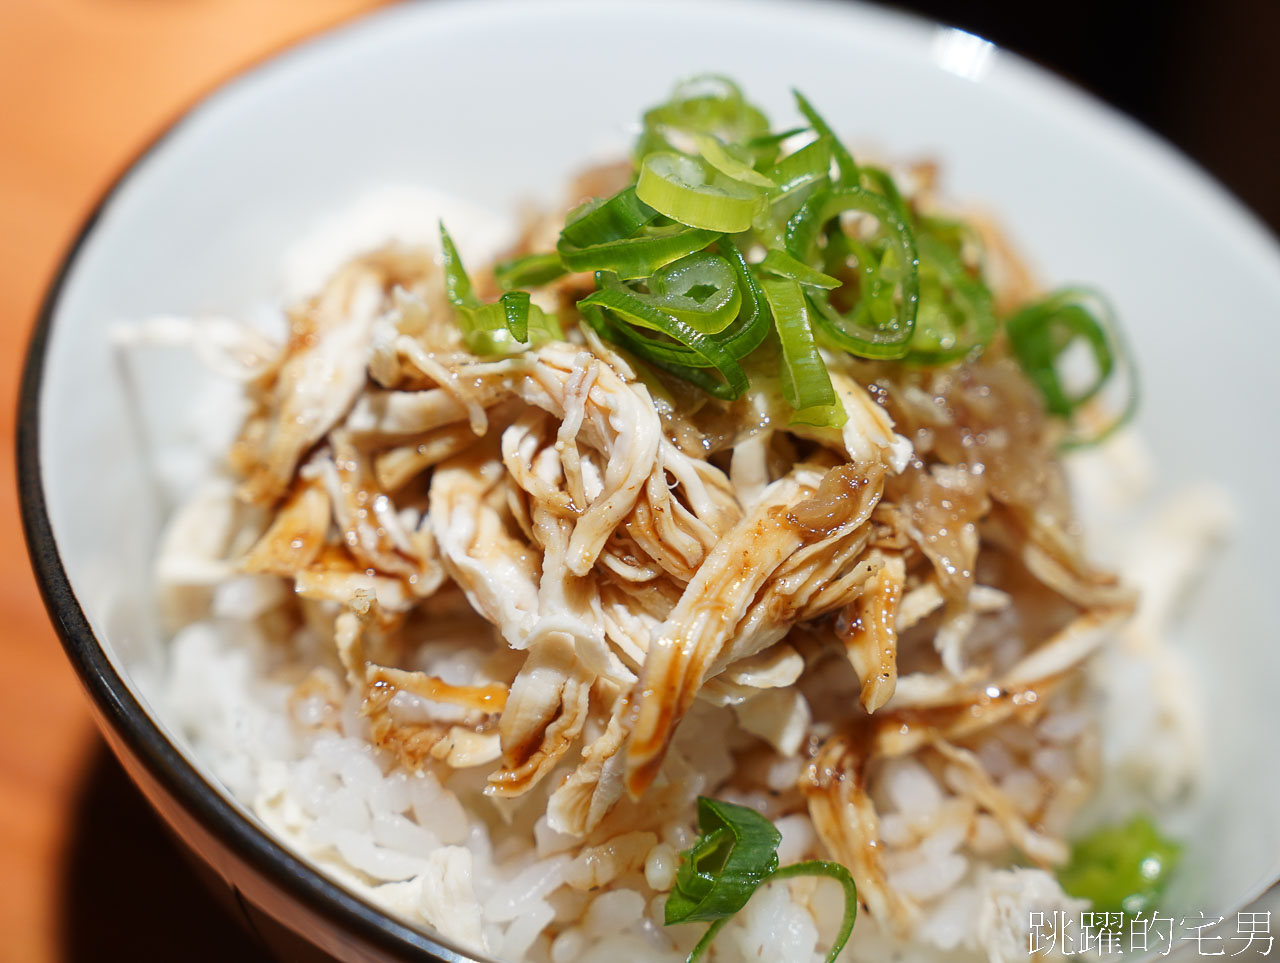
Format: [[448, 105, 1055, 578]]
[[760, 278, 845, 428]]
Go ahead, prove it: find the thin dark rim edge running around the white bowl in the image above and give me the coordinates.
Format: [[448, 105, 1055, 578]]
[[14, 0, 1280, 963]]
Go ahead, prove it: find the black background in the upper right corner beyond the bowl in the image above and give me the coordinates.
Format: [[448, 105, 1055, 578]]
[[893, 0, 1280, 233]]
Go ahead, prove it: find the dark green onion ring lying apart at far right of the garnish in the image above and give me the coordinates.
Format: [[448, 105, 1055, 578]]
[[1005, 280, 1138, 446]]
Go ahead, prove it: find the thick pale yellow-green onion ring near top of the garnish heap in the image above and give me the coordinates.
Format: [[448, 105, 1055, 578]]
[[636, 151, 764, 234]]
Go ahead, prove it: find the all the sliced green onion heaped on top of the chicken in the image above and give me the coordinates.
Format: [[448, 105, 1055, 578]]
[[442, 77, 1135, 443]]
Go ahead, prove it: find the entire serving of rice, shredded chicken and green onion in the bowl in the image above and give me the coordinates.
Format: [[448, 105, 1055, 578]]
[[137, 78, 1215, 963]]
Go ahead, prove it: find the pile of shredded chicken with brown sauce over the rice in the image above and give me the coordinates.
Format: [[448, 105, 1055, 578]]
[[160, 172, 1132, 927]]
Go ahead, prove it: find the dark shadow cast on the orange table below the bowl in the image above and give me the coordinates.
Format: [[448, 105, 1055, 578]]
[[60, 740, 273, 963]]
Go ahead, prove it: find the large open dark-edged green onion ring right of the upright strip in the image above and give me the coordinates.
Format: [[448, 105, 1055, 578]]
[[786, 187, 919, 359]]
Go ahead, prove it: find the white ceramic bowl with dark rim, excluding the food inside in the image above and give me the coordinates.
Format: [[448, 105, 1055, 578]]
[[20, 0, 1280, 959]]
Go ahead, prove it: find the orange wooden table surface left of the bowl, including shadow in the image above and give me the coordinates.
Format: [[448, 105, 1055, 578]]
[[0, 0, 378, 963]]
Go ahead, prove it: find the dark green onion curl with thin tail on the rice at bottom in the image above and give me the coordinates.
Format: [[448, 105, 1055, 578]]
[[666, 795, 858, 963]]
